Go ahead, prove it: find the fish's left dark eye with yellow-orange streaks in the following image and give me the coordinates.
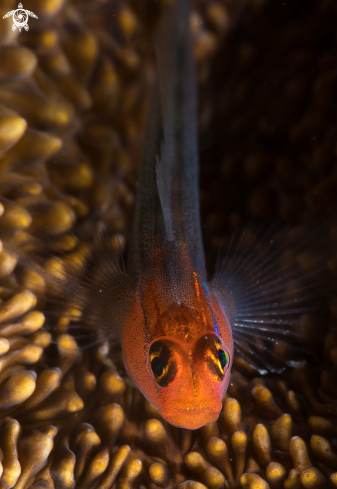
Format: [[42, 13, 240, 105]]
[[150, 341, 177, 387]]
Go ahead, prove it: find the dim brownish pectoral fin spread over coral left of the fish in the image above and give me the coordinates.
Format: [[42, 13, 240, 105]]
[[4, 230, 136, 341]]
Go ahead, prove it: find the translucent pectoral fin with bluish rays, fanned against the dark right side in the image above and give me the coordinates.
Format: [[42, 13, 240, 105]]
[[211, 226, 326, 372]]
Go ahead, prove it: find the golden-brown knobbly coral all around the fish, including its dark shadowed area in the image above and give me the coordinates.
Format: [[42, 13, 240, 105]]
[[0, 0, 337, 489]]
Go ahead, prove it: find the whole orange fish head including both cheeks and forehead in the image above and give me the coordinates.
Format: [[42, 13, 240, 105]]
[[122, 288, 233, 429]]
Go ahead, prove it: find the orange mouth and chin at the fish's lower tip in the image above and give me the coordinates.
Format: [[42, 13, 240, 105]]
[[161, 399, 222, 430]]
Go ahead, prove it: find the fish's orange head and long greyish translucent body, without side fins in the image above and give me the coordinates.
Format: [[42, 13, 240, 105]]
[[121, 0, 233, 429]]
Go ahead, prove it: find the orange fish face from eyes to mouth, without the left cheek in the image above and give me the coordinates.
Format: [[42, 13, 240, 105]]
[[147, 332, 231, 429]]
